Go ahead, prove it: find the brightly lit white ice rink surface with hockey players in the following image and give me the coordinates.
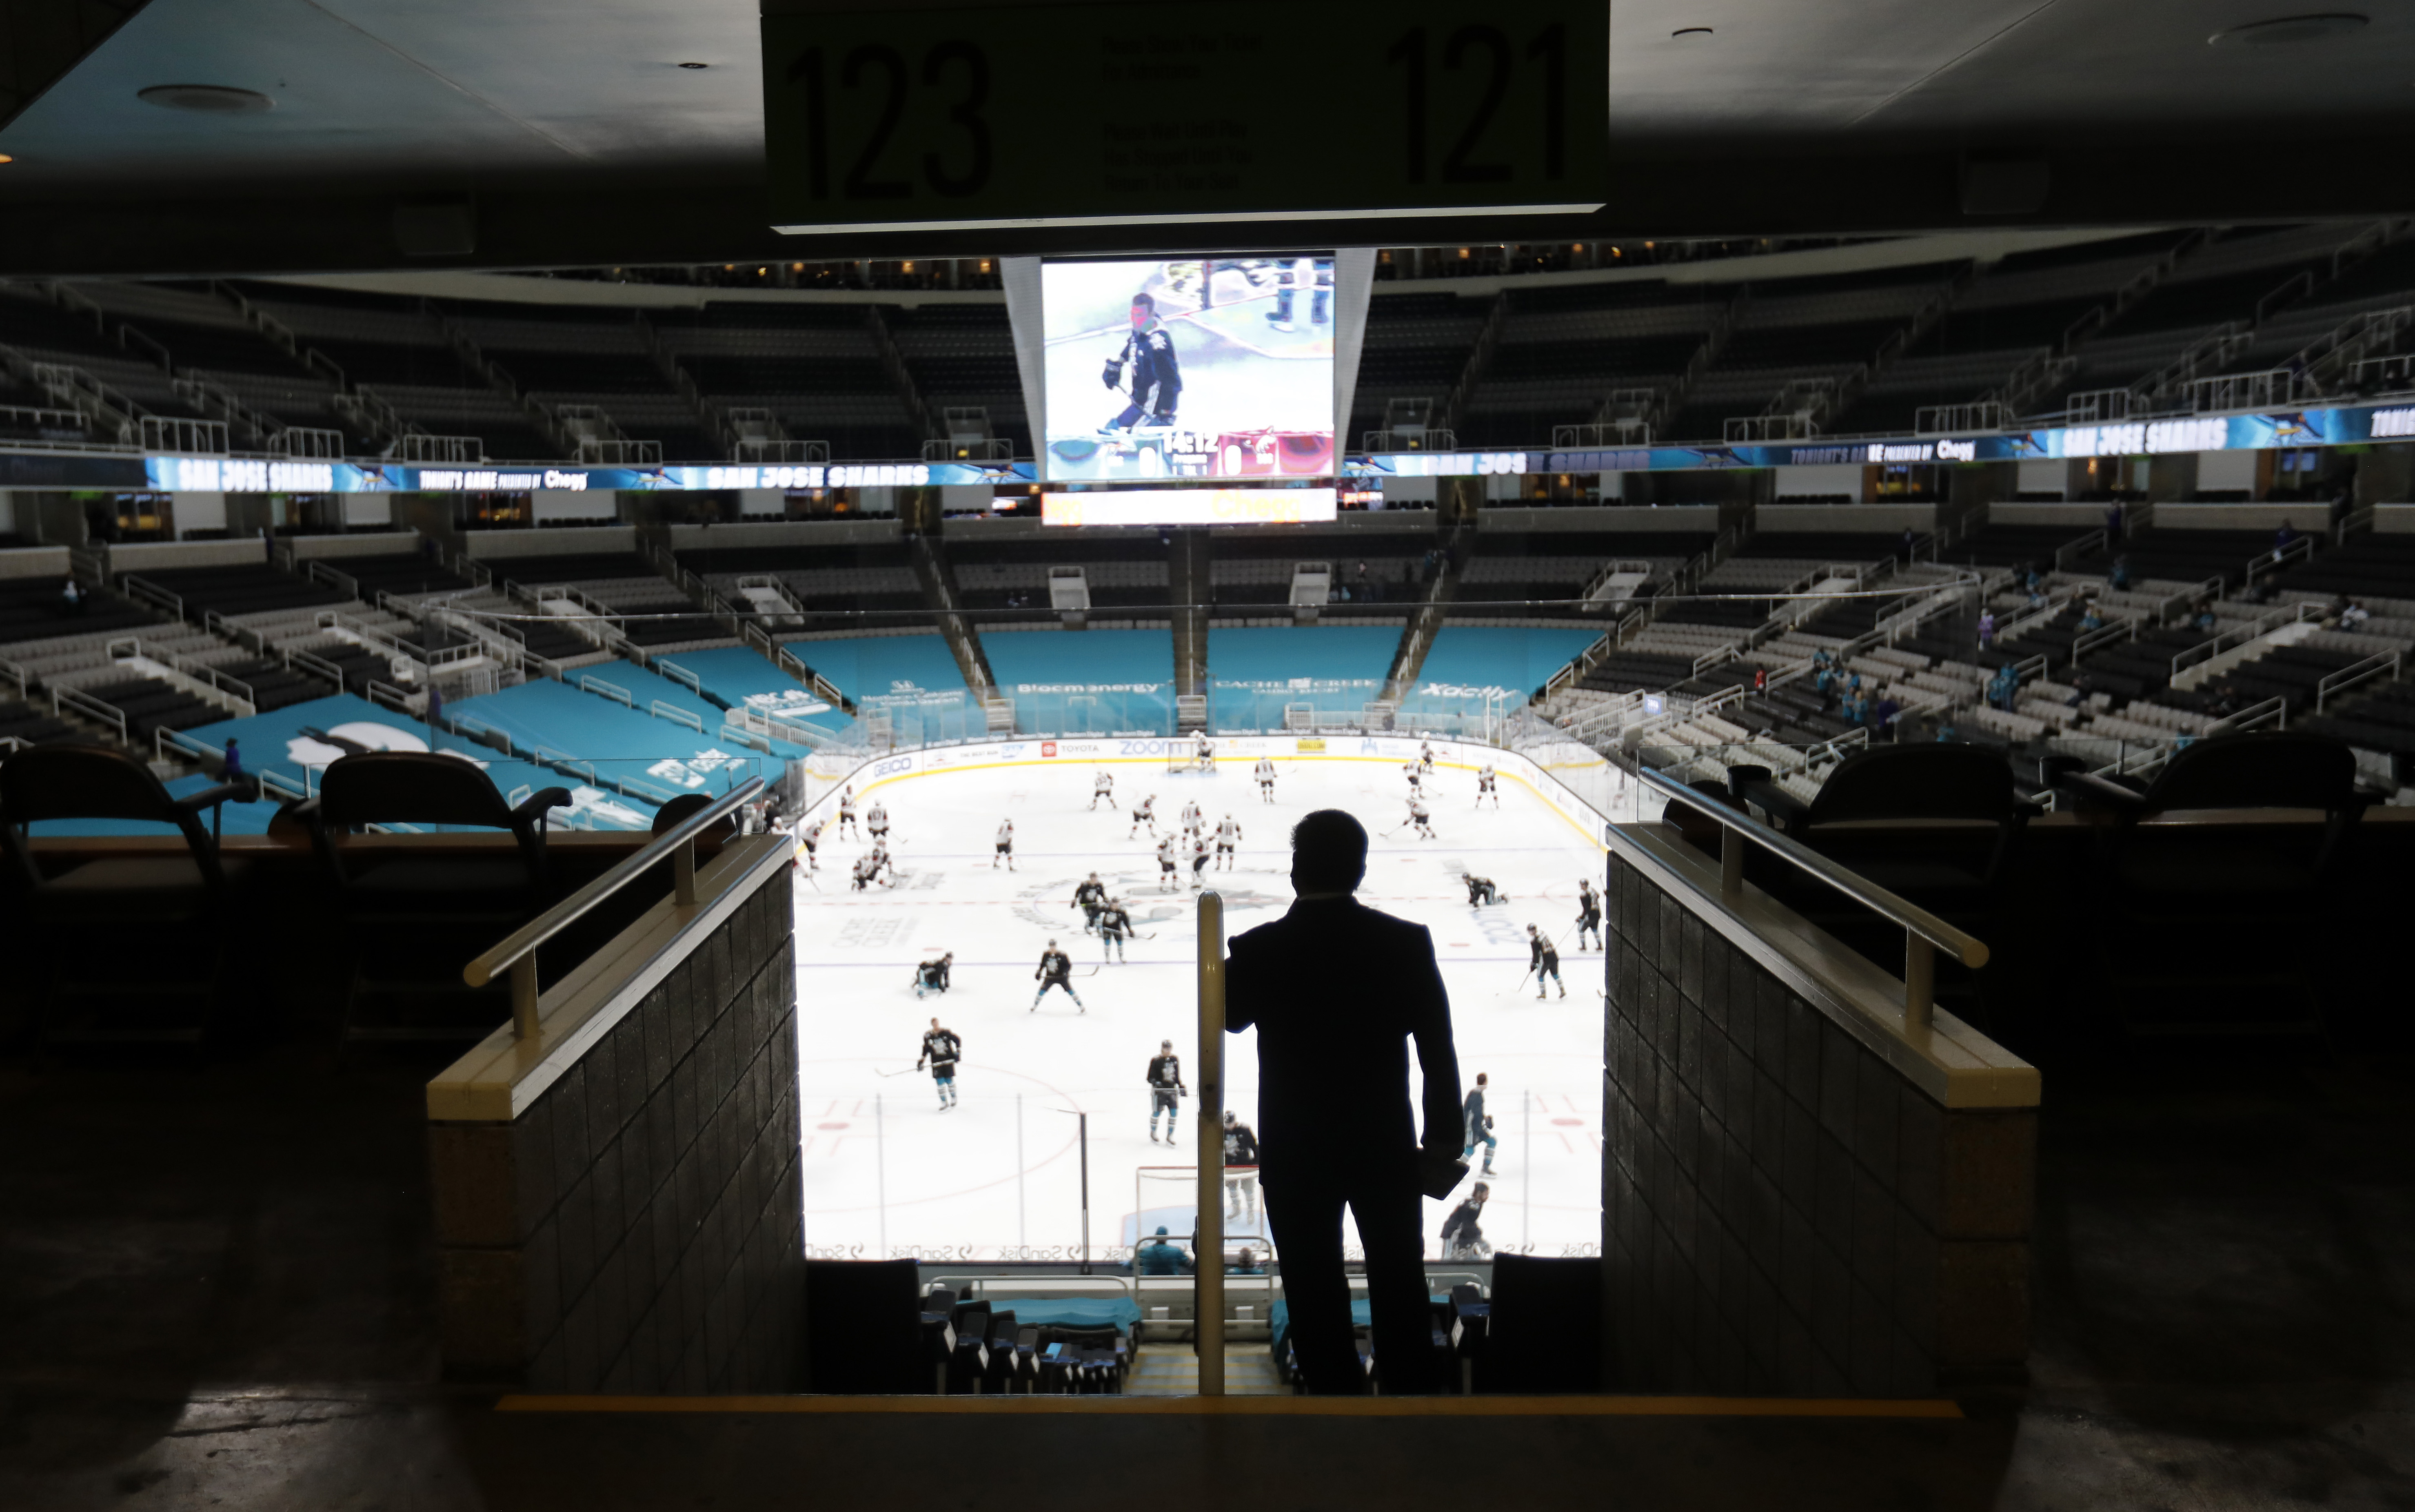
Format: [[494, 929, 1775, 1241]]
[[797, 741, 1604, 1258]]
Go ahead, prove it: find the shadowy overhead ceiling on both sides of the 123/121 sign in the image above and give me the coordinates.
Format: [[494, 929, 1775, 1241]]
[[0, 0, 2415, 273]]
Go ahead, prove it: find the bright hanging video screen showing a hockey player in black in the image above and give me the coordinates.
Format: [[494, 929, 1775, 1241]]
[[1041, 256, 1333, 478]]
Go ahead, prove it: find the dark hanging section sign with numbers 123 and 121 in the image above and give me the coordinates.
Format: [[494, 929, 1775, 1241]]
[[763, 0, 1611, 234]]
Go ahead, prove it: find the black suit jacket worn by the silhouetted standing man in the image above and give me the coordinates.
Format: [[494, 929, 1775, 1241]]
[[1224, 898, 1461, 1181]]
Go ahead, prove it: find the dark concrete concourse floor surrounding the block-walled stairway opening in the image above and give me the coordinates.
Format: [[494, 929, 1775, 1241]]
[[0, 1033, 2415, 1512]]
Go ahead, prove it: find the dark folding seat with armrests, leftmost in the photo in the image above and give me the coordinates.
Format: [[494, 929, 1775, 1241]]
[[0, 744, 249, 1039]]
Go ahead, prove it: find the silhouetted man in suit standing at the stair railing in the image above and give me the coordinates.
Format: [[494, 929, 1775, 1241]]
[[1224, 809, 1463, 1394]]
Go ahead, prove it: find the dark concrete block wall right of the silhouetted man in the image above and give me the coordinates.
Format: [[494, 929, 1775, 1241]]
[[1601, 853, 2036, 1396]]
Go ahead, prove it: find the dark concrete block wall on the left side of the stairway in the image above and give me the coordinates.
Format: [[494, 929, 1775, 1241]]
[[430, 867, 804, 1394]]
